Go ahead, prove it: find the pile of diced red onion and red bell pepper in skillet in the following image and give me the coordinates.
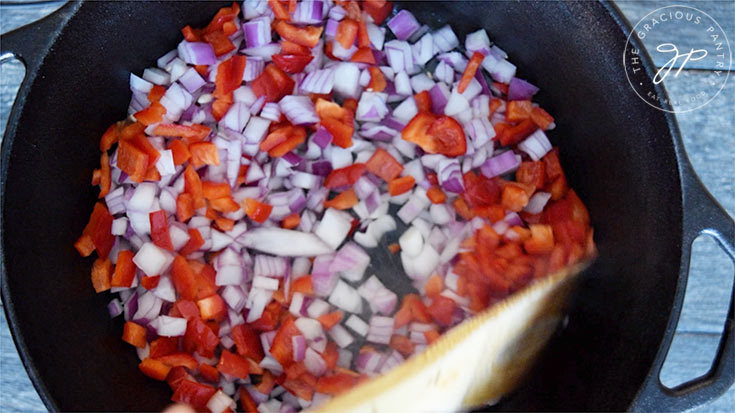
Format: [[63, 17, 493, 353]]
[[75, 0, 595, 413]]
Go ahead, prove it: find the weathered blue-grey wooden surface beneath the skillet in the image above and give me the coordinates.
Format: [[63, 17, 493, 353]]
[[0, 0, 735, 412]]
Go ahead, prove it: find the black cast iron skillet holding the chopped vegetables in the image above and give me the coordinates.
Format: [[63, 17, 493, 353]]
[[0, 2, 735, 411]]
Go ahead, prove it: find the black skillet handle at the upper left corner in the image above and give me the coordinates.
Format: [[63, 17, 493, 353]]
[[0, 1, 81, 72]]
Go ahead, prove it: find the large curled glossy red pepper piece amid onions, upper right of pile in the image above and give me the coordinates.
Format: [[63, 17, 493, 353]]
[[401, 112, 467, 157]]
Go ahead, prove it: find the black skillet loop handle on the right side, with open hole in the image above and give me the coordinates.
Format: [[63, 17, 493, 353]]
[[631, 156, 735, 411]]
